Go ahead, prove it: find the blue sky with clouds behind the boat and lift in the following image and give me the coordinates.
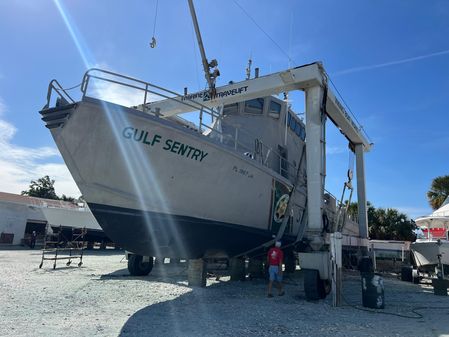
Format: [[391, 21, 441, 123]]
[[0, 0, 449, 217]]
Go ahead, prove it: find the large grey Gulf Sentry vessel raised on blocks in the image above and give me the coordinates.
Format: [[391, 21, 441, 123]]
[[41, 69, 314, 258]]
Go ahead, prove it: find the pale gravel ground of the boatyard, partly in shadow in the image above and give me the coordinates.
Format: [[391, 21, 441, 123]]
[[0, 250, 449, 337]]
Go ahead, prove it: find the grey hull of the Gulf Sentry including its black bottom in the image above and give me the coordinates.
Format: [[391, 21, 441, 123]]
[[44, 99, 299, 257]]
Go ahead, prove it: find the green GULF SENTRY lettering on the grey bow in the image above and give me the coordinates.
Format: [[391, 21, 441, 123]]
[[122, 126, 208, 162]]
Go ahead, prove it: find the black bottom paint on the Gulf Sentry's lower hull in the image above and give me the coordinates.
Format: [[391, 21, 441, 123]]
[[89, 203, 293, 259]]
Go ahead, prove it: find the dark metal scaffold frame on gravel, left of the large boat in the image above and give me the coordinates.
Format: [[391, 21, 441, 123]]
[[39, 226, 87, 269]]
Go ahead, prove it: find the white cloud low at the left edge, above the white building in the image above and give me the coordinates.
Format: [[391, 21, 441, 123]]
[[0, 99, 81, 197]]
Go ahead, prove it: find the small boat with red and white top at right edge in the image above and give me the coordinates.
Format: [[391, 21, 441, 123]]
[[410, 197, 449, 270]]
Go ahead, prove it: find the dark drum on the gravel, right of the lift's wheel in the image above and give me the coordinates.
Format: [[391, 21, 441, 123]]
[[361, 273, 385, 309]]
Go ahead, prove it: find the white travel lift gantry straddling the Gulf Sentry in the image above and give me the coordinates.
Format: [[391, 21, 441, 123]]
[[144, 62, 372, 305]]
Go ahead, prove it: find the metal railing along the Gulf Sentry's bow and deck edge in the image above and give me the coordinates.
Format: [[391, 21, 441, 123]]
[[77, 68, 297, 179]]
